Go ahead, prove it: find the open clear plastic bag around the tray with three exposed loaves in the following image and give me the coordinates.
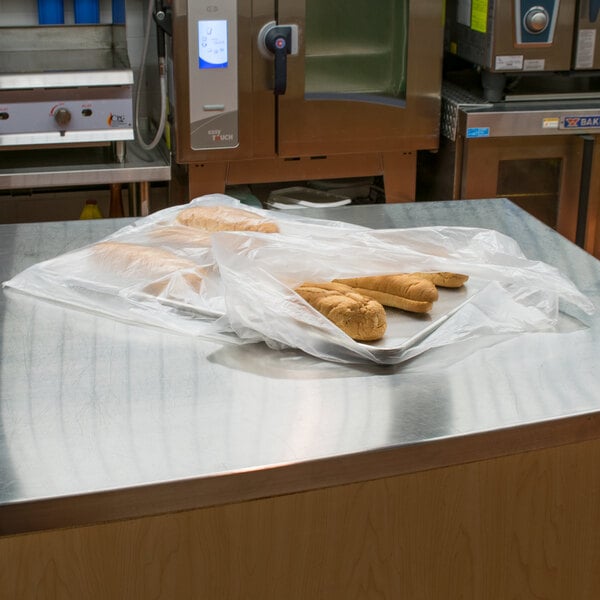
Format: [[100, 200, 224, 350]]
[[207, 227, 595, 364]]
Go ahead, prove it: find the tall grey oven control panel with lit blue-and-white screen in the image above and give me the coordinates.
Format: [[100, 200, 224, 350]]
[[187, 0, 239, 150]]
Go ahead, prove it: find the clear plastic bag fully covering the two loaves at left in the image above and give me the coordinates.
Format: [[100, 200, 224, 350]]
[[4, 194, 365, 343]]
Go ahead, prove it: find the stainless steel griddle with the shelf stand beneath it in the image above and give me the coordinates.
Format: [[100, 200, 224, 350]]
[[0, 25, 171, 214]]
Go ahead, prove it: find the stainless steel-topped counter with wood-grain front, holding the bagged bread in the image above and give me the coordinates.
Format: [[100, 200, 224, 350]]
[[0, 199, 600, 600]]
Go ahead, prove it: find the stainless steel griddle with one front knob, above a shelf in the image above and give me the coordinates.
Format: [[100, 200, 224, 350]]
[[0, 25, 134, 152]]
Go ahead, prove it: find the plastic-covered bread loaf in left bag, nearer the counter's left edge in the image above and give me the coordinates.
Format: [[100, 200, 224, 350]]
[[91, 242, 202, 294]]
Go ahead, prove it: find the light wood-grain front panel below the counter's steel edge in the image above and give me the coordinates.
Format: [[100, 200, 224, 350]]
[[0, 440, 600, 600]]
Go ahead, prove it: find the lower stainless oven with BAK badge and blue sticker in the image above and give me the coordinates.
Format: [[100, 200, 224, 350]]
[[419, 81, 600, 252]]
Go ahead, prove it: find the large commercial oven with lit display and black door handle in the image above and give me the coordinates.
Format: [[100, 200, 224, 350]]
[[168, 0, 443, 201]]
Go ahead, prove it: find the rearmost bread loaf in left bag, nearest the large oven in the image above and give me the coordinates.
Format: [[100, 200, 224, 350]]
[[176, 206, 279, 233]]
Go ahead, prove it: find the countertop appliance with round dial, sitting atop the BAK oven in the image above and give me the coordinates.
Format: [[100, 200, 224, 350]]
[[445, 0, 600, 101]]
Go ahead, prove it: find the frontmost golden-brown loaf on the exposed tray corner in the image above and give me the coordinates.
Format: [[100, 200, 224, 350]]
[[295, 283, 387, 342]]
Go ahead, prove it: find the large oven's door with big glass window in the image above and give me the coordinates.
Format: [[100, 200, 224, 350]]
[[274, 0, 443, 157]]
